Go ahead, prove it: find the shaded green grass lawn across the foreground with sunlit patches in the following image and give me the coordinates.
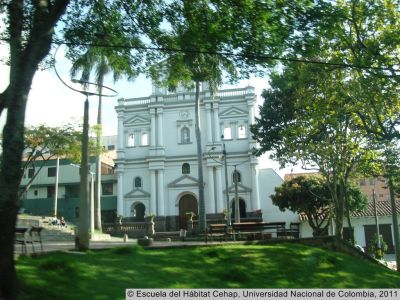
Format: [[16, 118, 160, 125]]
[[17, 244, 400, 299]]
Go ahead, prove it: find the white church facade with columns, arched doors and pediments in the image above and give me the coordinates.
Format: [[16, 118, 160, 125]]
[[115, 84, 299, 230]]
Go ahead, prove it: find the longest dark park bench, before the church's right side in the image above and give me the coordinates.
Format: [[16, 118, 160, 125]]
[[232, 222, 286, 240]]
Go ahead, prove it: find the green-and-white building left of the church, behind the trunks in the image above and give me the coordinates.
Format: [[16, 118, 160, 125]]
[[20, 144, 117, 223]]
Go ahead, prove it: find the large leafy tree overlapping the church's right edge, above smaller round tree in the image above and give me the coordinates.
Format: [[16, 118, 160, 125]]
[[251, 64, 377, 237]]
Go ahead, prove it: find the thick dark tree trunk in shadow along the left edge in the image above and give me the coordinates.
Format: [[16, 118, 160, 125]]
[[0, 0, 69, 299]]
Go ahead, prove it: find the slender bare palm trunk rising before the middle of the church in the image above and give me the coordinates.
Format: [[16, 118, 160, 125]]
[[195, 81, 207, 232]]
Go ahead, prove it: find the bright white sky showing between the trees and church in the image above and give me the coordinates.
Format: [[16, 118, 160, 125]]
[[0, 44, 301, 176]]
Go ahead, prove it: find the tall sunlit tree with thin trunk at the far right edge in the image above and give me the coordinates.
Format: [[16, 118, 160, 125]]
[[318, 0, 400, 271]]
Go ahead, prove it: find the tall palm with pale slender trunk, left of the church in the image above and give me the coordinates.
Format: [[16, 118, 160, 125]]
[[69, 1, 142, 231]]
